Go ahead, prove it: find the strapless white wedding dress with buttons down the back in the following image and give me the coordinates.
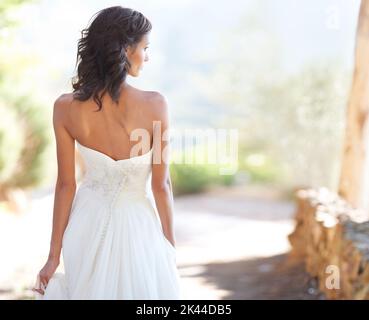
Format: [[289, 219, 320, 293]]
[[35, 141, 181, 300]]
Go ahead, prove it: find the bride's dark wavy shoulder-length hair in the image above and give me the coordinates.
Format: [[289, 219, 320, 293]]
[[72, 6, 152, 111]]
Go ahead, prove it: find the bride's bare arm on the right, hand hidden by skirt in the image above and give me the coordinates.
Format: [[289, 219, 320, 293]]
[[151, 94, 175, 246]]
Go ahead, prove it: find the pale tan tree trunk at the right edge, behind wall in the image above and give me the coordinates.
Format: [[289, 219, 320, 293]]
[[338, 0, 369, 207]]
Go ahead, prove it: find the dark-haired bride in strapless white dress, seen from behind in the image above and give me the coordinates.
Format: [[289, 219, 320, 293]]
[[33, 6, 181, 300]]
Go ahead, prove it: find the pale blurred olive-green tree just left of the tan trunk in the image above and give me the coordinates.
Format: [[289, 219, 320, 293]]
[[247, 61, 352, 190]]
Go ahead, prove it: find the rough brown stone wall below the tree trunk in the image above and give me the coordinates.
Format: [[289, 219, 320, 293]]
[[289, 188, 369, 299]]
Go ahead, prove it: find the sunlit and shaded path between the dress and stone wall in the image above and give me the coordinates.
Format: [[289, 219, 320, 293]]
[[172, 187, 324, 300]]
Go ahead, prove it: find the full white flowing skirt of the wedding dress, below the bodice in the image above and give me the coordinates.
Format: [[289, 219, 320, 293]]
[[36, 188, 181, 300]]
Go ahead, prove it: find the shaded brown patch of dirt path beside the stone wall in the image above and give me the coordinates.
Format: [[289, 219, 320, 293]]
[[202, 254, 324, 300]]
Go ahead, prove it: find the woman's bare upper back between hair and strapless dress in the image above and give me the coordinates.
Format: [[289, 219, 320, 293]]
[[63, 85, 159, 160]]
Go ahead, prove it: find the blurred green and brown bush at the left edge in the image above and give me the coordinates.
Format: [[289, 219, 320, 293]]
[[0, 95, 51, 189]]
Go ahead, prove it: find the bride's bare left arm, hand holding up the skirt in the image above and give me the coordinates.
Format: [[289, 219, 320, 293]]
[[33, 96, 76, 294]]
